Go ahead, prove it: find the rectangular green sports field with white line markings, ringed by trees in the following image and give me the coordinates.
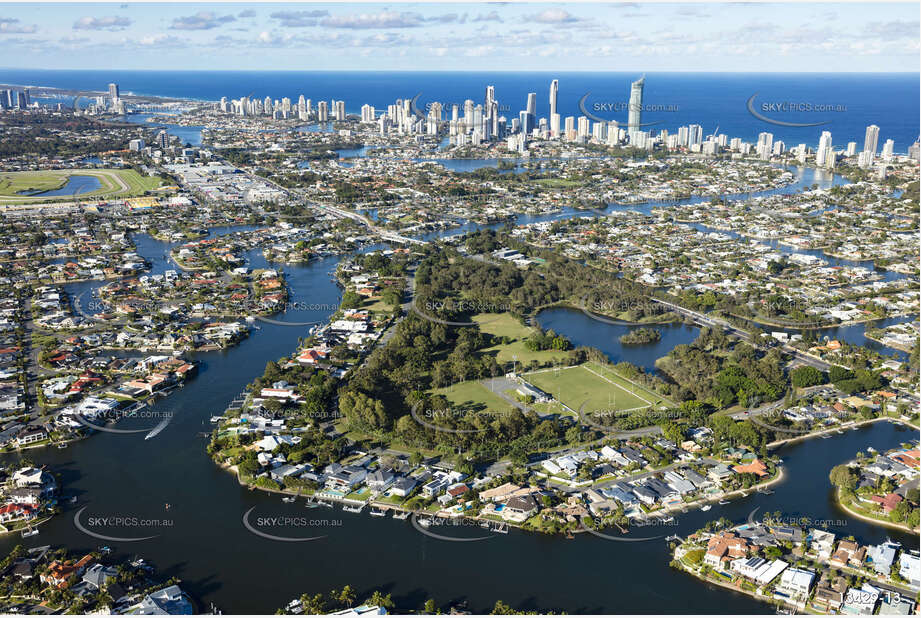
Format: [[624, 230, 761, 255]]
[[524, 363, 662, 413]]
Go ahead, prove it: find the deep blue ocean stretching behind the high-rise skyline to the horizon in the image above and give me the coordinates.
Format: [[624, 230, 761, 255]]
[[0, 69, 921, 153]]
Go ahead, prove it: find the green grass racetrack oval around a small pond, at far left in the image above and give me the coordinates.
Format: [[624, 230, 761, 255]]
[[0, 169, 162, 204]]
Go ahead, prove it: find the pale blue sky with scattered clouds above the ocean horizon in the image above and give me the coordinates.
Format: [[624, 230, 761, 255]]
[[0, 2, 921, 72]]
